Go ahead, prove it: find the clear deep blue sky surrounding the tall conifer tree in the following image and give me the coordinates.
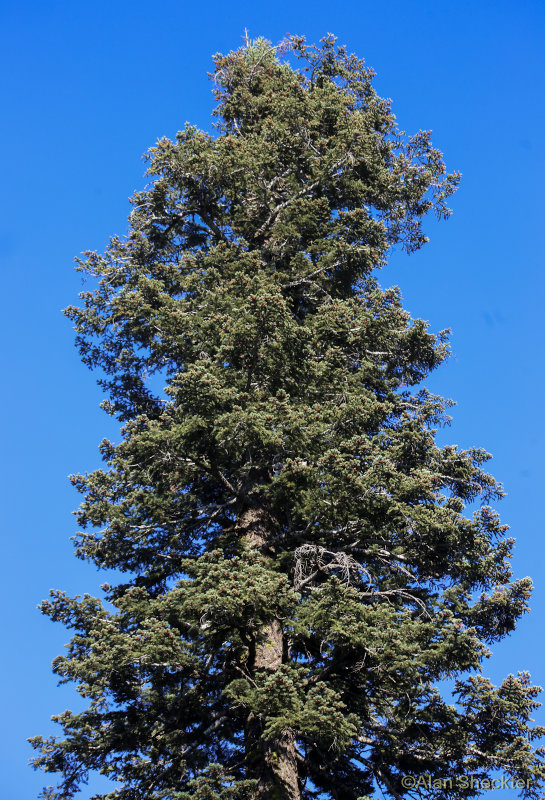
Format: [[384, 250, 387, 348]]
[[0, 0, 545, 800]]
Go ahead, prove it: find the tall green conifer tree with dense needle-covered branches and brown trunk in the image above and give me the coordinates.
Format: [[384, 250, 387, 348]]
[[32, 36, 545, 800]]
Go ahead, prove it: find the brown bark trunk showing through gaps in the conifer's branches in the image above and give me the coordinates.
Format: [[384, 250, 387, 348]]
[[239, 508, 301, 800]]
